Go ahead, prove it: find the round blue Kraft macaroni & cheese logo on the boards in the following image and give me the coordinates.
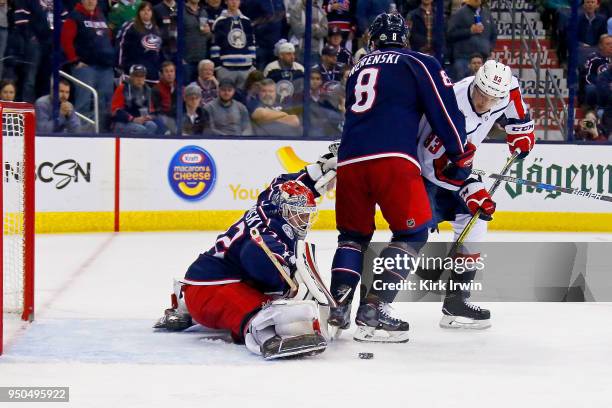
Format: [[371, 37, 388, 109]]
[[168, 146, 217, 201]]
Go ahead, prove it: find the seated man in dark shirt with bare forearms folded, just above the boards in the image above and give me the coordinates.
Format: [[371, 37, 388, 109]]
[[247, 78, 302, 137]]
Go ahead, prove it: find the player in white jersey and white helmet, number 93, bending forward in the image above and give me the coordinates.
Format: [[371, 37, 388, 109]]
[[418, 60, 535, 329]]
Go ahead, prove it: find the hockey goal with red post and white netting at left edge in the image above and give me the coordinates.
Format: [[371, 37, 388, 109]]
[[0, 101, 36, 353]]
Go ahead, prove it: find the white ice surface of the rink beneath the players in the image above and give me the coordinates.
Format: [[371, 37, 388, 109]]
[[0, 231, 612, 408]]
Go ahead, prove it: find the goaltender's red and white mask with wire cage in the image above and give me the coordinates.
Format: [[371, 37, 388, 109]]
[[278, 180, 317, 239]]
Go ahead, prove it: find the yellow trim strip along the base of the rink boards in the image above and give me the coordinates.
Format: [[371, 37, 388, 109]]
[[36, 210, 612, 233]]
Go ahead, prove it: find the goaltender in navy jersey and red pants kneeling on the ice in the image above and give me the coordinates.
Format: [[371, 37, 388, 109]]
[[154, 148, 336, 359]]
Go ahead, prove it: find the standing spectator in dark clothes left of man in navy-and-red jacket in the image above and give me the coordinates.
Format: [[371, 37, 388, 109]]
[[12, 0, 68, 103]]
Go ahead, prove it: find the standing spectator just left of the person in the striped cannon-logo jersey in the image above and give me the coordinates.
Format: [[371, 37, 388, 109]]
[[184, 0, 212, 83]]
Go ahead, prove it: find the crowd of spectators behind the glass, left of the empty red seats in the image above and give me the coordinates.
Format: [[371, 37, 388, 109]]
[[0, 0, 496, 137]]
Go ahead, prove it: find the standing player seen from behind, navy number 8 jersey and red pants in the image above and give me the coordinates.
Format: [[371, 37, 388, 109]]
[[329, 14, 473, 342]]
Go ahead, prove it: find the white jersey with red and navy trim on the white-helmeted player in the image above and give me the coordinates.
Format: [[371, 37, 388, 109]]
[[417, 76, 530, 190]]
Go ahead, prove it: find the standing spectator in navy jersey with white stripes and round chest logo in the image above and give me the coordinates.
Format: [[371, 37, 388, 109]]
[[210, 0, 255, 89]]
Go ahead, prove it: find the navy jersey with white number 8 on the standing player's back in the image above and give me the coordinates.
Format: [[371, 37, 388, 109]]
[[338, 48, 466, 168]]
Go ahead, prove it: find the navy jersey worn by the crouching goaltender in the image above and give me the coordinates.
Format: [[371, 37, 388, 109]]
[[183, 170, 319, 294]]
